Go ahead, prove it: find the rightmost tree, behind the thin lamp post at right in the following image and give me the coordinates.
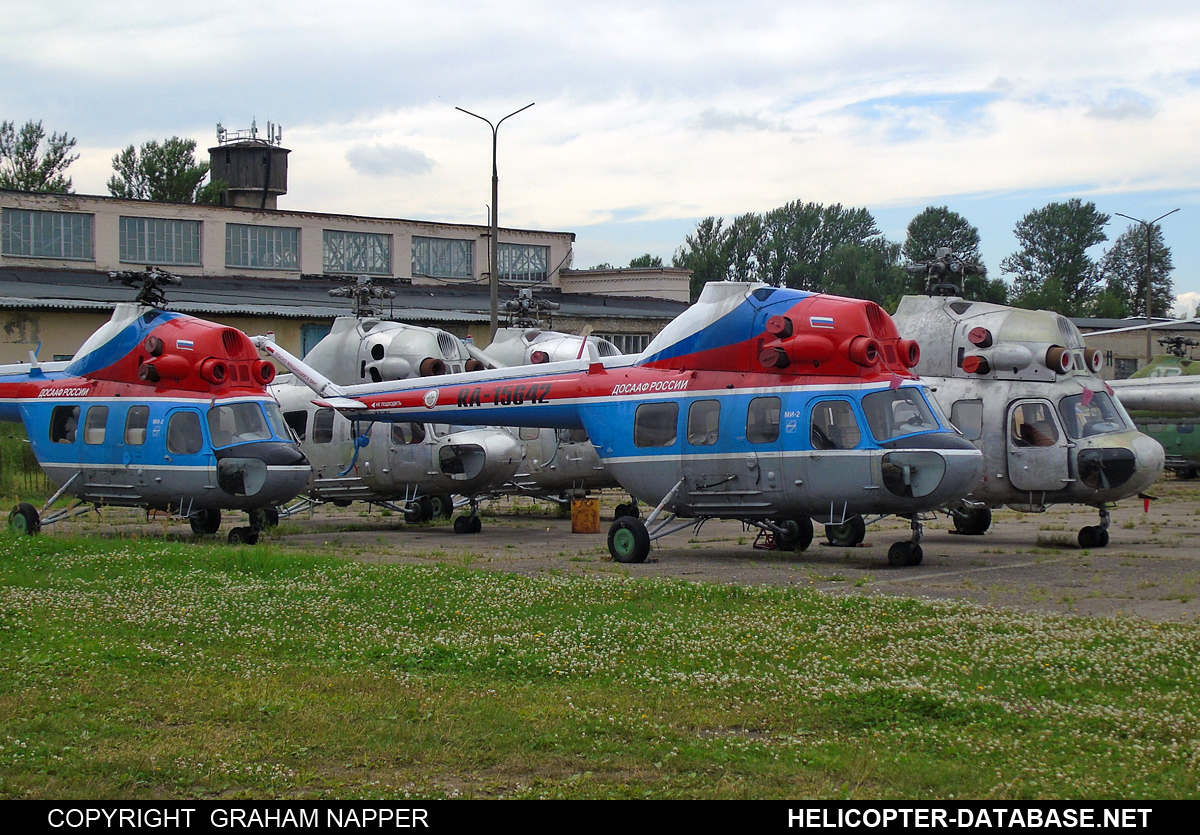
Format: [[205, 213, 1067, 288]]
[[1097, 223, 1175, 318]]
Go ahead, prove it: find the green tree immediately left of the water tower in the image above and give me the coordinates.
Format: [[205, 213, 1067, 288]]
[[108, 137, 224, 203]]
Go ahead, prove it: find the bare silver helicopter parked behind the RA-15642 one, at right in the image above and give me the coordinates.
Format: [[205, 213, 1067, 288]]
[[888, 248, 1164, 548]]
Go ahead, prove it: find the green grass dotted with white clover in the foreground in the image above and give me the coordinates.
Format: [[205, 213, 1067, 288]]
[[0, 536, 1200, 799]]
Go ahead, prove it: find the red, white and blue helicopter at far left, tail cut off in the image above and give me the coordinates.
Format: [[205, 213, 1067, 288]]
[[0, 269, 310, 543]]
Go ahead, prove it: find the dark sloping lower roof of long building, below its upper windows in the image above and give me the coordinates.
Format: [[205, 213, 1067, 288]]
[[0, 269, 686, 323]]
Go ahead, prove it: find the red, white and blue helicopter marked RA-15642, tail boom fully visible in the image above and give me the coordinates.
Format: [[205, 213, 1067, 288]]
[[262, 282, 983, 565]]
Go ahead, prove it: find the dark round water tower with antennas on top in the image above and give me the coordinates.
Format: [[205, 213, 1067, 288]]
[[209, 121, 292, 209]]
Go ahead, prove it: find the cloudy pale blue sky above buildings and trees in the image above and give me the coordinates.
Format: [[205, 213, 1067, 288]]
[[0, 0, 1200, 305]]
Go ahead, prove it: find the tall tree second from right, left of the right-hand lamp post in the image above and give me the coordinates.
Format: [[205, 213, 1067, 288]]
[[1000, 198, 1109, 317]]
